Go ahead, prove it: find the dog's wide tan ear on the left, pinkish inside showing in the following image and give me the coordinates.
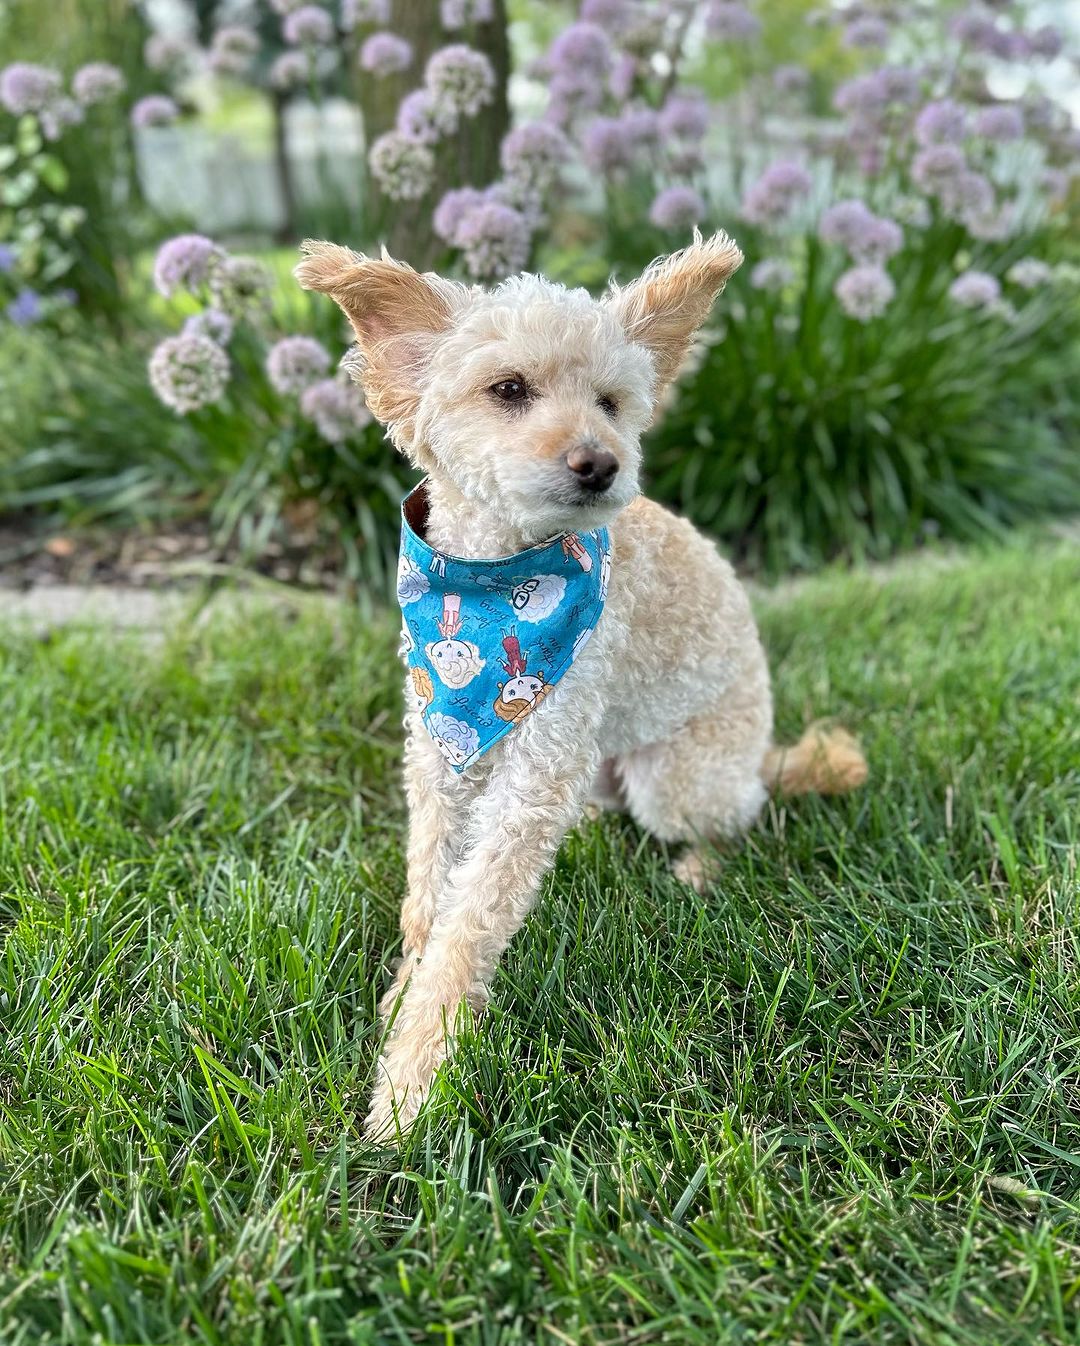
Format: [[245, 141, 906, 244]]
[[294, 241, 469, 441]]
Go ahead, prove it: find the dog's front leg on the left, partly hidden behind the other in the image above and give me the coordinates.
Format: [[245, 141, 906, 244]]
[[378, 715, 482, 1022]]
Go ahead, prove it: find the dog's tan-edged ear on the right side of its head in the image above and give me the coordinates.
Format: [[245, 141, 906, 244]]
[[605, 229, 742, 390]]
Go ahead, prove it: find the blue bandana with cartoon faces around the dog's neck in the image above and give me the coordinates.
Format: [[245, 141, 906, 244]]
[[397, 482, 611, 771]]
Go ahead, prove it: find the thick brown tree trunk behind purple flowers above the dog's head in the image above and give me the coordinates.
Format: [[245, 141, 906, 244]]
[[360, 0, 510, 269]]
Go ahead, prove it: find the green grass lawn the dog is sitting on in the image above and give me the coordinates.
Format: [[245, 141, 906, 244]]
[[0, 544, 1080, 1346]]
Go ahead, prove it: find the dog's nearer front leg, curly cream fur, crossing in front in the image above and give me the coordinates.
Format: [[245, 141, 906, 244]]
[[365, 705, 599, 1137]]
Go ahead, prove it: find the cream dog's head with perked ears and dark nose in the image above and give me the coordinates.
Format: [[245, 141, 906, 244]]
[[296, 233, 742, 540]]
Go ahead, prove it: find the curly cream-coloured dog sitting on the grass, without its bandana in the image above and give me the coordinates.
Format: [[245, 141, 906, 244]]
[[295, 232, 866, 1139]]
